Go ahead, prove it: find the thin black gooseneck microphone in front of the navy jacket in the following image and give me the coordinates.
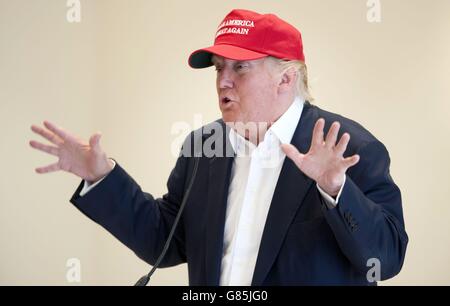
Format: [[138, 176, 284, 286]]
[[135, 155, 200, 287]]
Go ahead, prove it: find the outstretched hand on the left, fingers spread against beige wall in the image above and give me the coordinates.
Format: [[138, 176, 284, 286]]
[[30, 121, 114, 183]]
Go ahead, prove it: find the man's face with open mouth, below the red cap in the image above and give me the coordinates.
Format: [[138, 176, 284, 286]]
[[212, 56, 278, 124]]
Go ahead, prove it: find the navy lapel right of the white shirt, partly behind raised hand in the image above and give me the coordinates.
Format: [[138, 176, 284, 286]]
[[252, 103, 317, 286]]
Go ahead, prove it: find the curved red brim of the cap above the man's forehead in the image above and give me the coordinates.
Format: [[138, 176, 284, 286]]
[[189, 45, 268, 68]]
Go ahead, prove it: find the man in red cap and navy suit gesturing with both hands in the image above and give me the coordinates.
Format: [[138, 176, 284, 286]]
[[31, 10, 408, 285]]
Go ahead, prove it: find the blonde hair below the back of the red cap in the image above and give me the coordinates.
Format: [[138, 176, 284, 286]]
[[269, 56, 314, 102]]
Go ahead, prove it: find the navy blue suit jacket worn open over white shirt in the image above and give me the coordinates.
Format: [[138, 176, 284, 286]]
[[71, 103, 408, 285]]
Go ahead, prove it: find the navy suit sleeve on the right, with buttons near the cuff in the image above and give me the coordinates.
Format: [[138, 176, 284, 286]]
[[323, 141, 408, 280]]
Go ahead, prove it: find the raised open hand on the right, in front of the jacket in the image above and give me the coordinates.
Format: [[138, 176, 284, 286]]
[[282, 119, 359, 197]]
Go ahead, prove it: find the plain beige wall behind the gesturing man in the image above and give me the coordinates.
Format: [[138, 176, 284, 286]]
[[0, 0, 450, 285]]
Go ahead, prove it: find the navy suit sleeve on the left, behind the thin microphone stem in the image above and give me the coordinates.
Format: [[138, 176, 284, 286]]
[[70, 157, 188, 267]]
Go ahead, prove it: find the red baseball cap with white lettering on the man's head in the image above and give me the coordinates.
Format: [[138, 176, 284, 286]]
[[189, 10, 305, 68]]
